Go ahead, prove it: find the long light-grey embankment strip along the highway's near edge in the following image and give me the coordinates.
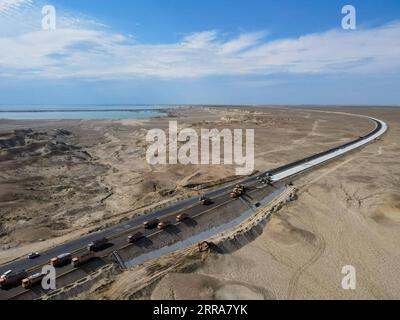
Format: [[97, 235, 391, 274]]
[[125, 187, 285, 268]]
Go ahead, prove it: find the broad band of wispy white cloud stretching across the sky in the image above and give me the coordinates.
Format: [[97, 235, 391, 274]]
[[0, 0, 400, 79]]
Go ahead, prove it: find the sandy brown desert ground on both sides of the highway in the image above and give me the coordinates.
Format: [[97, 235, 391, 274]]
[[0, 108, 400, 299]]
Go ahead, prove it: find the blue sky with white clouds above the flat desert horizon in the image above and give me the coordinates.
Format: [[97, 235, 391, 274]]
[[0, 0, 400, 105]]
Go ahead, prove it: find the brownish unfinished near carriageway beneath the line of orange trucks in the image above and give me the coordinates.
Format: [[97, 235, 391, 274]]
[[0, 182, 278, 300]]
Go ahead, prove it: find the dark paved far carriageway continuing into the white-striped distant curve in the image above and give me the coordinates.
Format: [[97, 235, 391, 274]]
[[0, 113, 388, 299]]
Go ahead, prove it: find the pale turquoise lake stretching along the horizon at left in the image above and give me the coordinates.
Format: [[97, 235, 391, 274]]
[[0, 105, 170, 120]]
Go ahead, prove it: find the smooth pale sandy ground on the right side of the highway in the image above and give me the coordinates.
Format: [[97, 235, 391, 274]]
[[141, 109, 400, 299]]
